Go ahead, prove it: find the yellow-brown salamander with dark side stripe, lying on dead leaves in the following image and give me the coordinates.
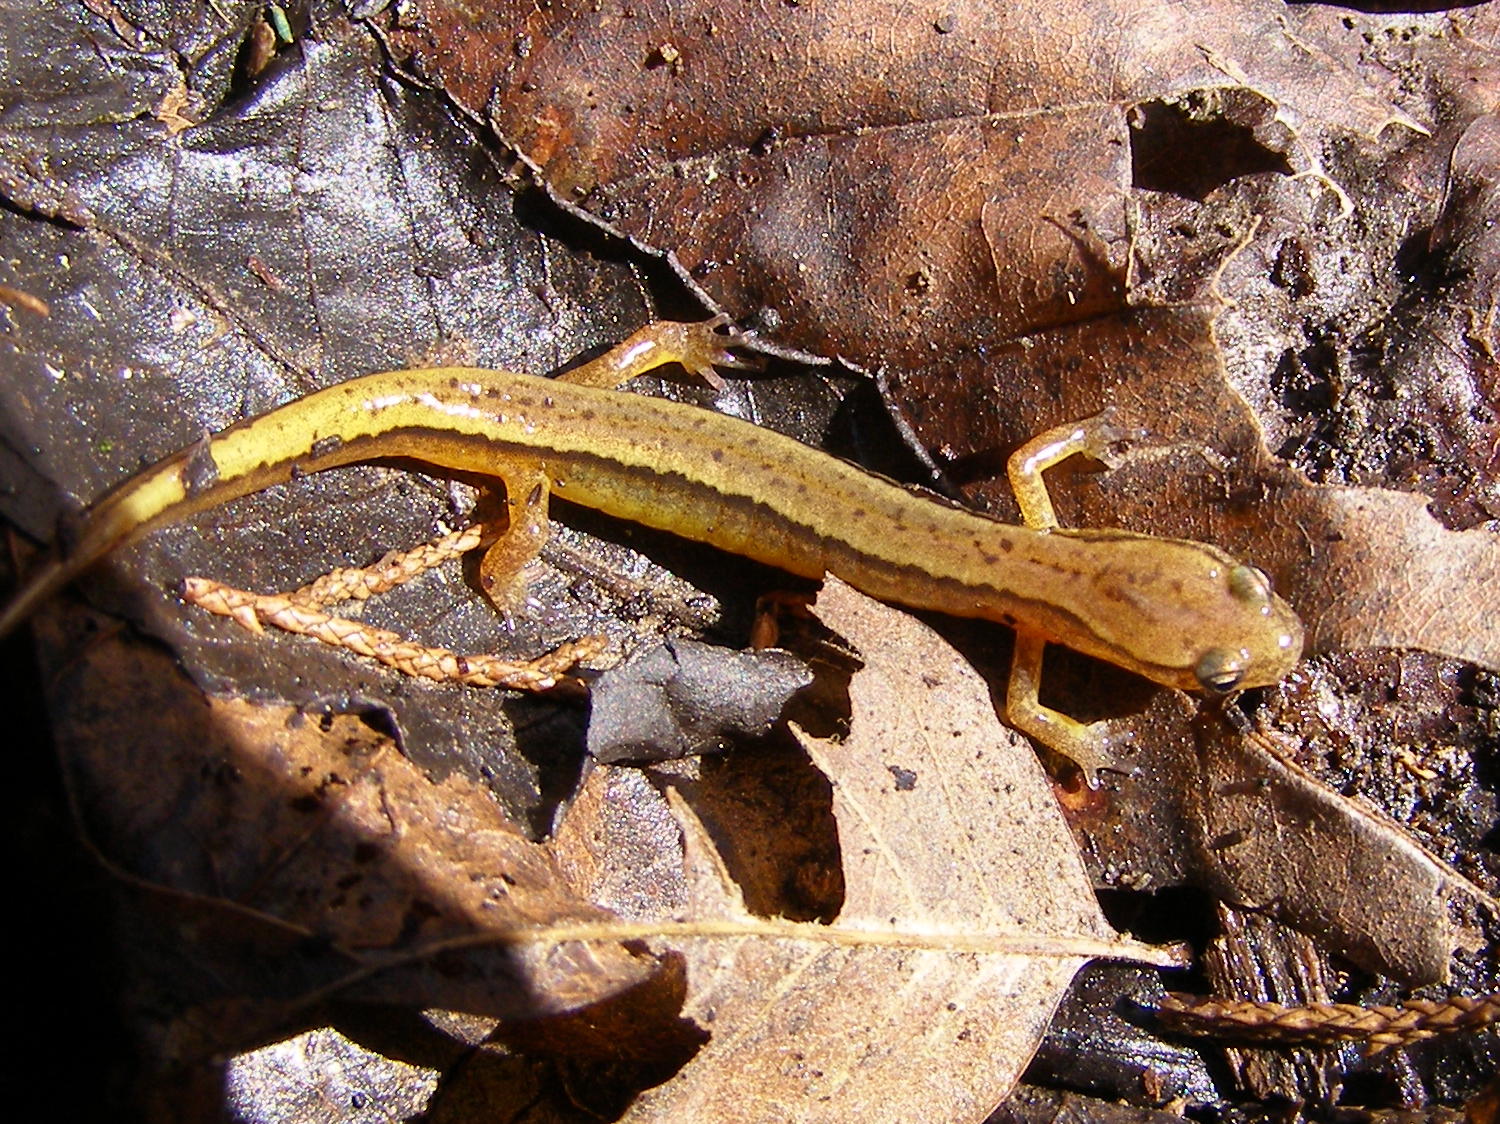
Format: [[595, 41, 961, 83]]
[[0, 320, 1302, 776]]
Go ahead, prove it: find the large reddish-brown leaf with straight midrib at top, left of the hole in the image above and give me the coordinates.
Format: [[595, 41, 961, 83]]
[[387, 0, 1421, 360]]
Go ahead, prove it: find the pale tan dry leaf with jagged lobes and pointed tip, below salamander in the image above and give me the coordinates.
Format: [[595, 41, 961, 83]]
[[591, 579, 1175, 1124]]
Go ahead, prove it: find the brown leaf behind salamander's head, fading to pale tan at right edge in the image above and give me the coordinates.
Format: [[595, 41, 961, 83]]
[[903, 308, 1500, 693]]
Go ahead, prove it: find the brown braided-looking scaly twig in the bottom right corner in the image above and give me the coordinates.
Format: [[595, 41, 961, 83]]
[[1160, 992, 1500, 1053]]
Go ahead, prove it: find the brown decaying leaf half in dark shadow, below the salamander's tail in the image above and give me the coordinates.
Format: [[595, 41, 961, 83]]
[[36, 600, 678, 1059]]
